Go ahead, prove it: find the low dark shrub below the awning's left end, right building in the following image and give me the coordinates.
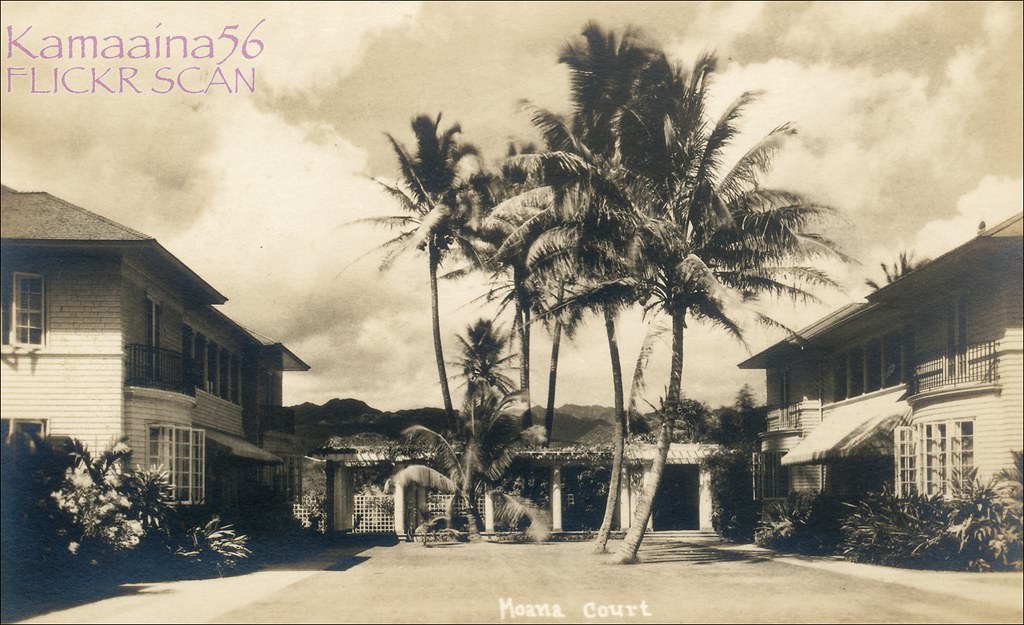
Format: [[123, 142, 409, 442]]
[[754, 493, 844, 554]]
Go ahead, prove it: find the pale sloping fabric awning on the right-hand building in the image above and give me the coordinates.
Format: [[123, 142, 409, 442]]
[[781, 406, 907, 465]]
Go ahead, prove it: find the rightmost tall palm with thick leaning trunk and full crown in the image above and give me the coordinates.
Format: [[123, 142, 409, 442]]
[[606, 55, 837, 563]]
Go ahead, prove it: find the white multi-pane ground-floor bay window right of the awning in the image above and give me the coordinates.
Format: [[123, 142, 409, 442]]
[[894, 419, 975, 495]]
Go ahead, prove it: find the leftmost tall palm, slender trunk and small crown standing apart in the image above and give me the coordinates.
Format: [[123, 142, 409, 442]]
[[361, 114, 479, 427]]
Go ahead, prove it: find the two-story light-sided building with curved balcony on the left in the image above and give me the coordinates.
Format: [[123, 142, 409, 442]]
[[0, 186, 309, 509]]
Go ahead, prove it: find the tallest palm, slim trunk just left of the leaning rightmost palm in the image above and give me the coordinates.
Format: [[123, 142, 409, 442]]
[[497, 23, 653, 551]]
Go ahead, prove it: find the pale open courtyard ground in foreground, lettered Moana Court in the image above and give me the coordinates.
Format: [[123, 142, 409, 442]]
[[9, 533, 1024, 623]]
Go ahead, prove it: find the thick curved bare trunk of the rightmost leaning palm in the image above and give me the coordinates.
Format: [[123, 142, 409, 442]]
[[618, 307, 686, 564]]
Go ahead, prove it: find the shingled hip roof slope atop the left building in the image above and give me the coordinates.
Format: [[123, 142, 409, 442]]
[[0, 186, 153, 241]]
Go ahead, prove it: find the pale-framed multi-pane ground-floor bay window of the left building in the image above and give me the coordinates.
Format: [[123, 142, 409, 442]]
[[148, 425, 206, 503]]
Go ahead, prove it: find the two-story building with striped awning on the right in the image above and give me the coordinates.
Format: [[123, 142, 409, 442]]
[[739, 214, 1024, 501]]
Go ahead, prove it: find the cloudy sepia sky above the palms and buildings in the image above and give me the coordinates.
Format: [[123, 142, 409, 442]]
[[0, 2, 1024, 409]]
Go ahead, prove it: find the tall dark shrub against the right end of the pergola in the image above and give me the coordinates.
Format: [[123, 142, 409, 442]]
[[701, 450, 761, 542]]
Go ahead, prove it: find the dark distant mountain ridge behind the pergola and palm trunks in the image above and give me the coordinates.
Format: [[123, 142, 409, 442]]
[[293, 399, 614, 443]]
